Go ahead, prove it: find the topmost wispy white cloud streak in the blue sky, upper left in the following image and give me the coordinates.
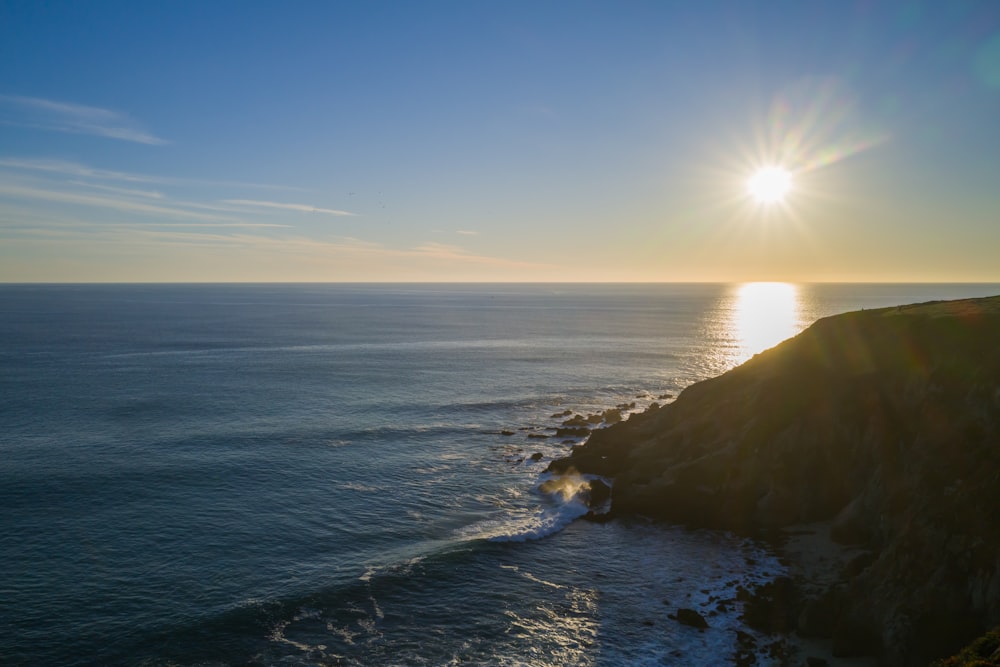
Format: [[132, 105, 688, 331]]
[[0, 95, 167, 146]]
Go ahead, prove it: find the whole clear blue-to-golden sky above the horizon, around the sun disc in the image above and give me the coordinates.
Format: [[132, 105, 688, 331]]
[[0, 0, 1000, 282]]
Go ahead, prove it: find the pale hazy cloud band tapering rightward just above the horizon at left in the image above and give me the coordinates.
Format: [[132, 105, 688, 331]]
[[0, 215, 554, 282]]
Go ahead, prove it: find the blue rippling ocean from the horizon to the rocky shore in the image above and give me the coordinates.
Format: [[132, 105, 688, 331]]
[[0, 285, 1000, 665]]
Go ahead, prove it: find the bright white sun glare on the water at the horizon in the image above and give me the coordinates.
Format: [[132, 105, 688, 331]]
[[731, 283, 799, 364]]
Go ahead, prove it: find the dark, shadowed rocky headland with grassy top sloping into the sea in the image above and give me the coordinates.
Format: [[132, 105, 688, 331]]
[[550, 297, 1000, 665]]
